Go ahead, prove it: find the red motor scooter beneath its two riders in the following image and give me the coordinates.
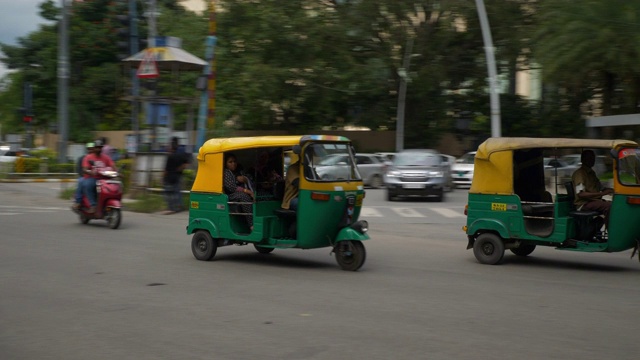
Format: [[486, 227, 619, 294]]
[[73, 167, 122, 229]]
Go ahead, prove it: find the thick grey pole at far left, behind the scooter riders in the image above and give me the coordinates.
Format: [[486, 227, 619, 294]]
[[58, 0, 70, 163]]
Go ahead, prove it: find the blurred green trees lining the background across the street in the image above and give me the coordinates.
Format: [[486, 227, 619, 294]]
[[0, 0, 640, 147]]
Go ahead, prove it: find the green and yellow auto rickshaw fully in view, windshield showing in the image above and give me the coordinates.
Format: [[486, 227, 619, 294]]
[[187, 135, 369, 271]]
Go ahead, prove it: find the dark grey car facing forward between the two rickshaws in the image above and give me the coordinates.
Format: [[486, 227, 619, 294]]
[[384, 149, 449, 201]]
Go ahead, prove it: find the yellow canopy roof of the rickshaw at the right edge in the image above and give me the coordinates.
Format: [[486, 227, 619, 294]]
[[469, 137, 638, 194]]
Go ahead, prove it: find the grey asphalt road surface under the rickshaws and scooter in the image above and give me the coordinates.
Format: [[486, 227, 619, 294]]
[[0, 184, 640, 360]]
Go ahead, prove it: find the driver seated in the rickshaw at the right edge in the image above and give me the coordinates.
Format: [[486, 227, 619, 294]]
[[571, 150, 613, 225]]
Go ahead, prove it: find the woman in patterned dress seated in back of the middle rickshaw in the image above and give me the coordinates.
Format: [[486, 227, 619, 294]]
[[223, 153, 254, 231]]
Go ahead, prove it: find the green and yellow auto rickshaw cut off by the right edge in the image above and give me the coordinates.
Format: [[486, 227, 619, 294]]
[[463, 138, 640, 264]]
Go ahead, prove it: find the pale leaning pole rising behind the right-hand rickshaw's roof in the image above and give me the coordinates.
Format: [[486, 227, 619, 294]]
[[476, 0, 502, 137]]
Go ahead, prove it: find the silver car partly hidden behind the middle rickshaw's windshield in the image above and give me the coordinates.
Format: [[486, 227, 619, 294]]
[[316, 153, 387, 189]]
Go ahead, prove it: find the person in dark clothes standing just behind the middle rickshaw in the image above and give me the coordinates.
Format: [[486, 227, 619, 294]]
[[162, 137, 189, 215]]
